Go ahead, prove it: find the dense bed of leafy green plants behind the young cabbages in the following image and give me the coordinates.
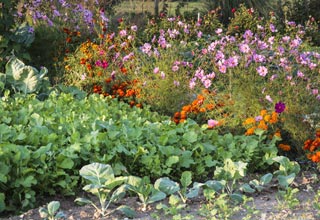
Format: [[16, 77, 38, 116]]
[[0, 91, 298, 215]]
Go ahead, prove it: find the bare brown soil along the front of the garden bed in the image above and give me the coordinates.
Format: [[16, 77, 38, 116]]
[[0, 172, 320, 220]]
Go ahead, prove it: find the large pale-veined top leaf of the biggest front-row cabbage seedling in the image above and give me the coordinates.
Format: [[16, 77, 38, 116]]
[[79, 163, 114, 185]]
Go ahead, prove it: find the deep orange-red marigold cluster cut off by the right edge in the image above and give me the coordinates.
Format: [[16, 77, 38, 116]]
[[303, 129, 320, 163]]
